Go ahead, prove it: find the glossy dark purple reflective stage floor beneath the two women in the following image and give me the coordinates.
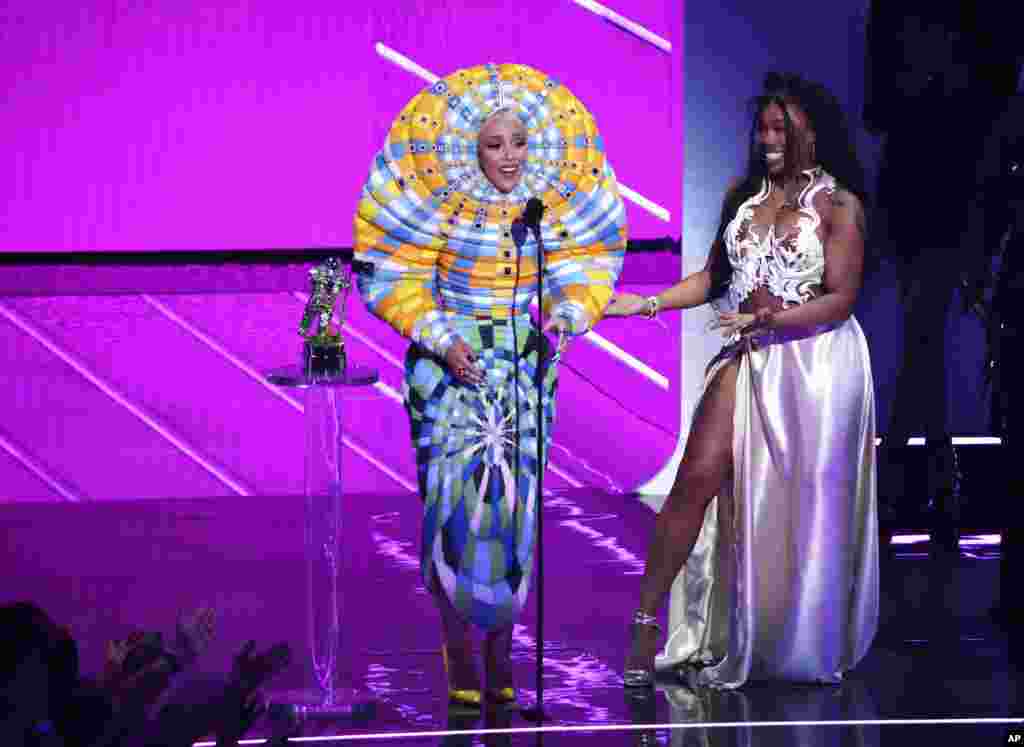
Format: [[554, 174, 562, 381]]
[[0, 491, 1024, 747]]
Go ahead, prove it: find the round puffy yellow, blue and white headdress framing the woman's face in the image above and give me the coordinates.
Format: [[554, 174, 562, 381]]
[[356, 65, 625, 248]]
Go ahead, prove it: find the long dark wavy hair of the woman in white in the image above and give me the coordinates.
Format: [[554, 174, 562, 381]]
[[711, 73, 867, 298]]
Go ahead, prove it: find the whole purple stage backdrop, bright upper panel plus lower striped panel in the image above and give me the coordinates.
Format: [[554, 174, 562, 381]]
[[0, 0, 683, 508]]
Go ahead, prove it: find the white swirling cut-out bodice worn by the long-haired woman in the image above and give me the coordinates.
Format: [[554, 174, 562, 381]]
[[722, 168, 837, 309]]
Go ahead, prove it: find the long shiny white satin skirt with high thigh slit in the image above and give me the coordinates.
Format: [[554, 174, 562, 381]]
[[657, 317, 879, 689]]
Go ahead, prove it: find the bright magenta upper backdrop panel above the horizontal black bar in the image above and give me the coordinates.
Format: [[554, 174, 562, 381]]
[[6, 0, 682, 251]]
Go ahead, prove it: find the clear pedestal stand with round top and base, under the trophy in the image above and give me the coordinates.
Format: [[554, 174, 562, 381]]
[[267, 366, 378, 719]]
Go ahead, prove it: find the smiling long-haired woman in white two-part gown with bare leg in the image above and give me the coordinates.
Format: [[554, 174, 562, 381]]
[[606, 74, 879, 688]]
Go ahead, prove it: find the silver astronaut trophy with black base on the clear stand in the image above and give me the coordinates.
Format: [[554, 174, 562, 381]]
[[299, 257, 352, 380]]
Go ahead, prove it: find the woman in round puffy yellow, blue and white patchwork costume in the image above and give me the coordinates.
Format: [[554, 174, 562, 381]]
[[355, 65, 626, 706]]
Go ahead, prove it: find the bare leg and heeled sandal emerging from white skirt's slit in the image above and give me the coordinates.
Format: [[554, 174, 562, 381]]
[[626, 360, 739, 671]]
